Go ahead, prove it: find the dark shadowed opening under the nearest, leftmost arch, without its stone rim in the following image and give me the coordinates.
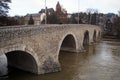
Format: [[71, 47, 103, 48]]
[[6, 50, 37, 73]]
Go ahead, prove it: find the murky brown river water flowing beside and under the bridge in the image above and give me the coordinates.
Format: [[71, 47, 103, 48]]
[[0, 40, 120, 80]]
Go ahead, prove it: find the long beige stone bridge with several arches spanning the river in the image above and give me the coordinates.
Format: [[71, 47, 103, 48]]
[[0, 24, 102, 74]]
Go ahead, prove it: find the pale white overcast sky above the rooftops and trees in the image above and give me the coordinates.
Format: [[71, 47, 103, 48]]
[[9, 0, 120, 16]]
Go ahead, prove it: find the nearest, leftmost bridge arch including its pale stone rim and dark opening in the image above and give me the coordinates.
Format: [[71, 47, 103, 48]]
[[1, 46, 39, 74]]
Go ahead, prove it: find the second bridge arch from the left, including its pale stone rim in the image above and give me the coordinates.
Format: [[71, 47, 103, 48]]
[[54, 33, 78, 73]]
